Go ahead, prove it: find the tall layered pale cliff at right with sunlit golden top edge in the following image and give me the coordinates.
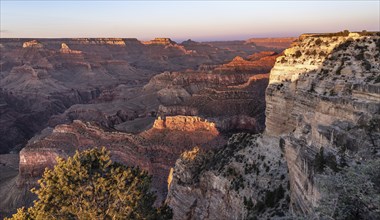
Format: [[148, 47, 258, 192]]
[[266, 33, 380, 214]]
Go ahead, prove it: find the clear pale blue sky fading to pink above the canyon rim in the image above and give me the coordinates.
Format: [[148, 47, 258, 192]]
[[0, 0, 380, 40]]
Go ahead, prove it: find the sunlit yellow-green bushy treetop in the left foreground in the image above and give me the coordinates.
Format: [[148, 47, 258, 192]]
[[7, 147, 171, 219]]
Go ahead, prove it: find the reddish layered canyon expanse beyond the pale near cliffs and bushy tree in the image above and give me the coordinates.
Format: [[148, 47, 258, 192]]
[[0, 38, 293, 215]]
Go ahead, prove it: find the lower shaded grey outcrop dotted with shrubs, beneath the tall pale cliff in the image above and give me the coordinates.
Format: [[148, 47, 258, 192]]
[[166, 134, 289, 219]]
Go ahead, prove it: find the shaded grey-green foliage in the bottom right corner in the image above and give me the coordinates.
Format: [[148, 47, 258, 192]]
[[315, 159, 380, 219]]
